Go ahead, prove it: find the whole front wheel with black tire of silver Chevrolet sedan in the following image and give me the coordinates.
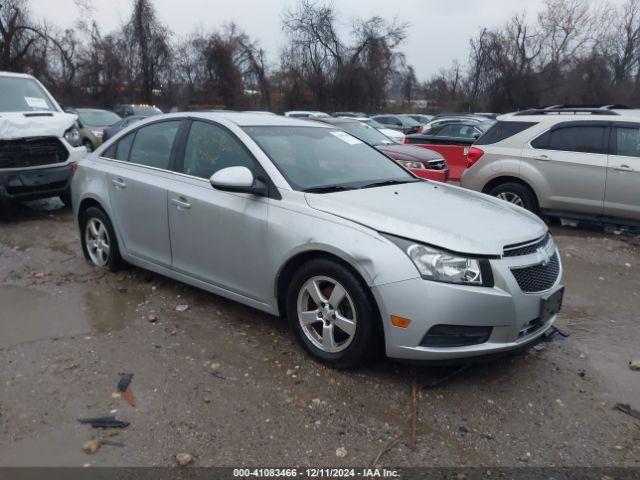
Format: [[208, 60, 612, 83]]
[[287, 259, 379, 368]]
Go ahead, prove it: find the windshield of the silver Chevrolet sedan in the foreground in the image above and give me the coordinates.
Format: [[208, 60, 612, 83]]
[[244, 126, 418, 191]]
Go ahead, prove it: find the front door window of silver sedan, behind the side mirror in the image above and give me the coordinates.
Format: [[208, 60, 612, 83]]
[[182, 122, 255, 179]]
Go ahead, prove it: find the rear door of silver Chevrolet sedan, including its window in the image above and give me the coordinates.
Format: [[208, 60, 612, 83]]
[[108, 120, 181, 267]]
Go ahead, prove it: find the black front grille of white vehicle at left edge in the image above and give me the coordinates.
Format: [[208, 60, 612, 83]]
[[0, 137, 69, 168]]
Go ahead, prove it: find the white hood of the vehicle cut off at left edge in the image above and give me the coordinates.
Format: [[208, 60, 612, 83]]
[[0, 112, 78, 140]]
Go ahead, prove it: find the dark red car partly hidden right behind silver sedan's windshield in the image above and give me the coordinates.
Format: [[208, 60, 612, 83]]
[[317, 118, 449, 182]]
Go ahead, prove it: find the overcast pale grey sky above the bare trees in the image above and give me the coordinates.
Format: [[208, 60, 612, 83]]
[[31, 0, 622, 79]]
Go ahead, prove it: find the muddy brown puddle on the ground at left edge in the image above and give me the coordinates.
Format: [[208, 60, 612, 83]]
[[0, 285, 142, 348]]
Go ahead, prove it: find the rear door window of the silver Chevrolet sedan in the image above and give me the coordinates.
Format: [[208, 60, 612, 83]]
[[129, 121, 180, 170]]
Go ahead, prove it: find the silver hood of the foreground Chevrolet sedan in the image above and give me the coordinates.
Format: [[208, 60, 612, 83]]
[[306, 182, 547, 255]]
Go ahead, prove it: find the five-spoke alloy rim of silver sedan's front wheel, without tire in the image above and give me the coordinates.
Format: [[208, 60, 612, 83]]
[[297, 276, 357, 353]]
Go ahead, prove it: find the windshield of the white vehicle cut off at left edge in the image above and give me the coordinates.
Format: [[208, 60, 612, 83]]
[[0, 77, 58, 112]]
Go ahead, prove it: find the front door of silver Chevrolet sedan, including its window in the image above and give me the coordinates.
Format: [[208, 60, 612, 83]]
[[166, 120, 273, 303]]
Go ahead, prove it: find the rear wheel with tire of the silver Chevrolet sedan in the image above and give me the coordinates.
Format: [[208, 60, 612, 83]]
[[80, 207, 124, 272]]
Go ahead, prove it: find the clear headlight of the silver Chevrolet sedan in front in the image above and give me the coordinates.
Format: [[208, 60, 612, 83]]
[[384, 235, 493, 287]]
